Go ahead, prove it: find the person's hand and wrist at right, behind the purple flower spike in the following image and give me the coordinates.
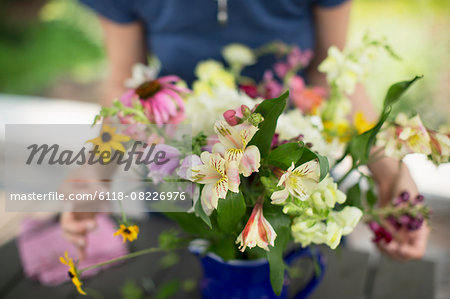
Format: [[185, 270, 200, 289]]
[[370, 161, 430, 261]]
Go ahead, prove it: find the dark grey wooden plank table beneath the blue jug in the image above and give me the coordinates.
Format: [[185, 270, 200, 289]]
[[0, 216, 434, 299]]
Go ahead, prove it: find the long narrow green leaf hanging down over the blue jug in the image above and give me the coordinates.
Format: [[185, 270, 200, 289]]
[[264, 207, 291, 296]]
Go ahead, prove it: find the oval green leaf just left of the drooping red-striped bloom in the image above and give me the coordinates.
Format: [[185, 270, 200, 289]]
[[217, 191, 247, 233]]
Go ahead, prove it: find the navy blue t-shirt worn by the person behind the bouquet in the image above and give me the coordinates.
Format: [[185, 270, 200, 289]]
[[80, 0, 346, 82]]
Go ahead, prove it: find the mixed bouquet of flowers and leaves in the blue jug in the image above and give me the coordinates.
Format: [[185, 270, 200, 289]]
[[60, 38, 450, 298]]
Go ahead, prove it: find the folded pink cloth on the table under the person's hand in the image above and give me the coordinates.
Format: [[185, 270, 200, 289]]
[[18, 215, 128, 286]]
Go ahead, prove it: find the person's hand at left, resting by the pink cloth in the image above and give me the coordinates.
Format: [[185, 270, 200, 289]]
[[60, 212, 97, 260]]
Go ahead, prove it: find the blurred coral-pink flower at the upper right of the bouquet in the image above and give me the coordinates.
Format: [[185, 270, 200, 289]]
[[289, 75, 326, 113]]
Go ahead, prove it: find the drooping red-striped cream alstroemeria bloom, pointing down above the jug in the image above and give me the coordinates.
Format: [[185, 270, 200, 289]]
[[236, 202, 277, 252]]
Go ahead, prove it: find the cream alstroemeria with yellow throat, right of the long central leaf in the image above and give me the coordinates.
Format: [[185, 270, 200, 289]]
[[270, 160, 319, 204]]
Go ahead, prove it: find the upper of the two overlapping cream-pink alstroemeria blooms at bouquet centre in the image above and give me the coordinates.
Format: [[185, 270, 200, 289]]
[[213, 121, 261, 177]]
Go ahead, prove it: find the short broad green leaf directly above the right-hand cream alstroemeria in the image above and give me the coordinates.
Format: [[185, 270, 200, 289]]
[[267, 142, 305, 169]]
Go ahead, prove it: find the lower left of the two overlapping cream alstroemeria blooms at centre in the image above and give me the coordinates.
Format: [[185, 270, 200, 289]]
[[192, 152, 239, 215]]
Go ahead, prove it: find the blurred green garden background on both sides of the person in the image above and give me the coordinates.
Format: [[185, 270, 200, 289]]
[[0, 0, 450, 127]]
